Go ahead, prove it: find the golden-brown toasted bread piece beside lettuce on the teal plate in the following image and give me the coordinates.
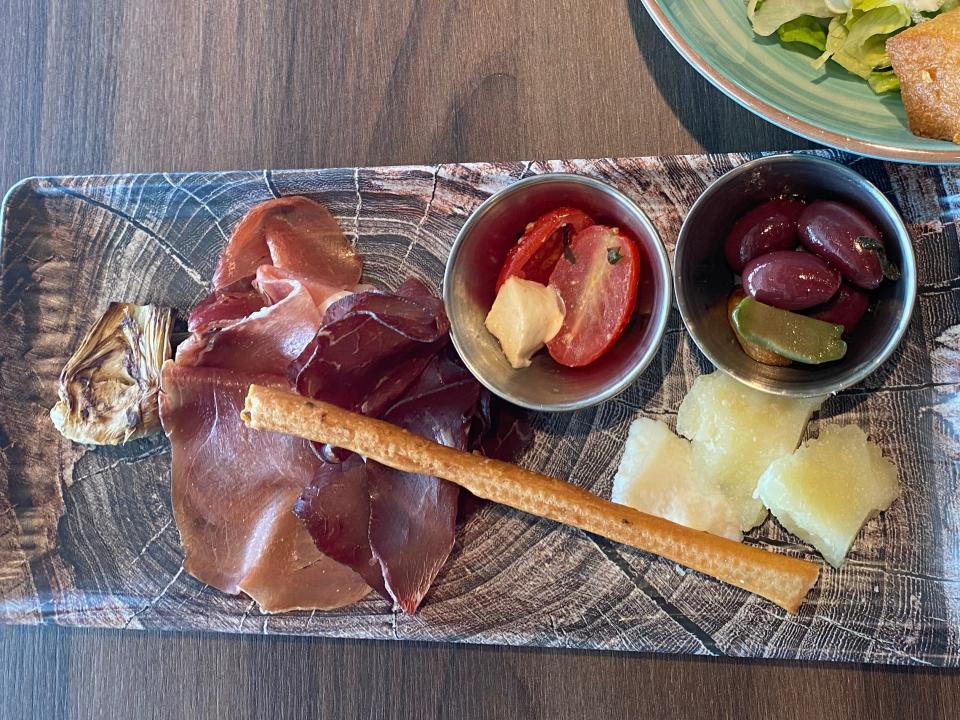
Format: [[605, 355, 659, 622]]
[[887, 8, 960, 143]]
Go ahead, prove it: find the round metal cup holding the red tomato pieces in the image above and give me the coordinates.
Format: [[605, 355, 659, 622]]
[[443, 173, 672, 411]]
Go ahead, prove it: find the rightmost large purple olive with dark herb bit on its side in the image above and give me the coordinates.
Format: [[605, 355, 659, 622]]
[[798, 200, 883, 290]]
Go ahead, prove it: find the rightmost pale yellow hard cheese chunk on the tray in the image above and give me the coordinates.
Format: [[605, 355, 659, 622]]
[[756, 424, 900, 567]]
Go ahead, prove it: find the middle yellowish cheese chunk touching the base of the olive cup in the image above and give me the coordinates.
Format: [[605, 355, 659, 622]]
[[677, 371, 825, 530]]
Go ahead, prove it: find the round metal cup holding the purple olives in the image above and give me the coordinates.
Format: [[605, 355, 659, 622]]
[[673, 155, 917, 397]]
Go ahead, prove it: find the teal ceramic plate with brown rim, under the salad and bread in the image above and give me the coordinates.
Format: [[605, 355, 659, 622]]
[[643, 0, 960, 164]]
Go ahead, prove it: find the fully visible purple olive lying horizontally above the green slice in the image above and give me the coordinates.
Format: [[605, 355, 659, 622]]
[[743, 250, 840, 310]]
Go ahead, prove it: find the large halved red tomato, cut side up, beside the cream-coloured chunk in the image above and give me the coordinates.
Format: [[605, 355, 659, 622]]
[[547, 225, 640, 367]]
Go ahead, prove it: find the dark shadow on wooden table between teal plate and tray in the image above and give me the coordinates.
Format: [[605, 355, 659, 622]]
[[627, 0, 817, 152]]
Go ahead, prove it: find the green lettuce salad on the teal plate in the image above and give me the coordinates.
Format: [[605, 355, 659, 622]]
[[747, 0, 960, 93]]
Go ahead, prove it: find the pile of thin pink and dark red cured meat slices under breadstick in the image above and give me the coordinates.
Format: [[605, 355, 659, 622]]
[[167, 197, 489, 612]]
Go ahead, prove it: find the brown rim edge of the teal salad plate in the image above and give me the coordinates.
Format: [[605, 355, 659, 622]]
[[641, 0, 960, 165]]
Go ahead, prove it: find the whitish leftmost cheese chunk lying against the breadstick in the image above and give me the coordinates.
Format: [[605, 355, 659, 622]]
[[610, 418, 741, 540]]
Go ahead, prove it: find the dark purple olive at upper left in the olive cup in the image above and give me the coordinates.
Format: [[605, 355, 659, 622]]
[[723, 199, 806, 273]]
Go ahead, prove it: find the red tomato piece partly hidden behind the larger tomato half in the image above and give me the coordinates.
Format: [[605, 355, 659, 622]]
[[496, 208, 593, 292]]
